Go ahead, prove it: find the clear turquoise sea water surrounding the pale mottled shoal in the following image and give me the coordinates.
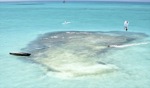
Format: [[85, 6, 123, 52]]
[[0, 2, 150, 88]]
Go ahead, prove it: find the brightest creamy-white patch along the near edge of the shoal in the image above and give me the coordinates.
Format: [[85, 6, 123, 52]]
[[47, 63, 119, 79]]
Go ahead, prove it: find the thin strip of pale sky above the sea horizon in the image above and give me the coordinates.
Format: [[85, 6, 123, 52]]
[[0, 0, 150, 2]]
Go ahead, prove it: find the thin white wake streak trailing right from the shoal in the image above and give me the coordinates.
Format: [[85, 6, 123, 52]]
[[109, 42, 150, 48]]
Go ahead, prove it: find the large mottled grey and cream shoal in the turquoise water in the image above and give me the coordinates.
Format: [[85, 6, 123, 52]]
[[22, 31, 147, 77]]
